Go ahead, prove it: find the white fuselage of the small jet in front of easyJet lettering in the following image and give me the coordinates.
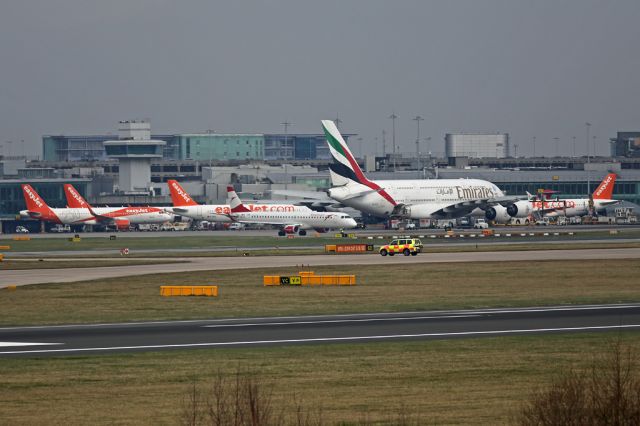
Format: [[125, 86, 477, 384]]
[[231, 207, 356, 229]]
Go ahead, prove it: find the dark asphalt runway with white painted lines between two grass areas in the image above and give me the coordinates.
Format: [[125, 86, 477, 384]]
[[0, 304, 640, 357]]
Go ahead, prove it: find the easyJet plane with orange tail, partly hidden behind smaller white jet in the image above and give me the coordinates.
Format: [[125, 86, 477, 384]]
[[165, 179, 310, 222]]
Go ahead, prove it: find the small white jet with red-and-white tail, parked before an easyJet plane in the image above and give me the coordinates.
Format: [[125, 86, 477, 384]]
[[227, 186, 356, 236]]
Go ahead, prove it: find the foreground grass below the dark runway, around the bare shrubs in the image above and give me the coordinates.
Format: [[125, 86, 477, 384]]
[[0, 333, 640, 425]]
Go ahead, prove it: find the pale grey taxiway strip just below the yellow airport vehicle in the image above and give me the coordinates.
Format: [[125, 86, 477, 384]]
[[0, 248, 640, 288]]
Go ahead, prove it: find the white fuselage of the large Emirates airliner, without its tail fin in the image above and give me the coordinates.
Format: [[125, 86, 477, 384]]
[[329, 179, 504, 219]]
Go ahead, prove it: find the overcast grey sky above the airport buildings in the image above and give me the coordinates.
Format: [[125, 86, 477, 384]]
[[0, 0, 640, 155]]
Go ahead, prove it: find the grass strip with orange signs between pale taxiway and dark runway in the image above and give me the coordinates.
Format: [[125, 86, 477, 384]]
[[0, 258, 640, 325]]
